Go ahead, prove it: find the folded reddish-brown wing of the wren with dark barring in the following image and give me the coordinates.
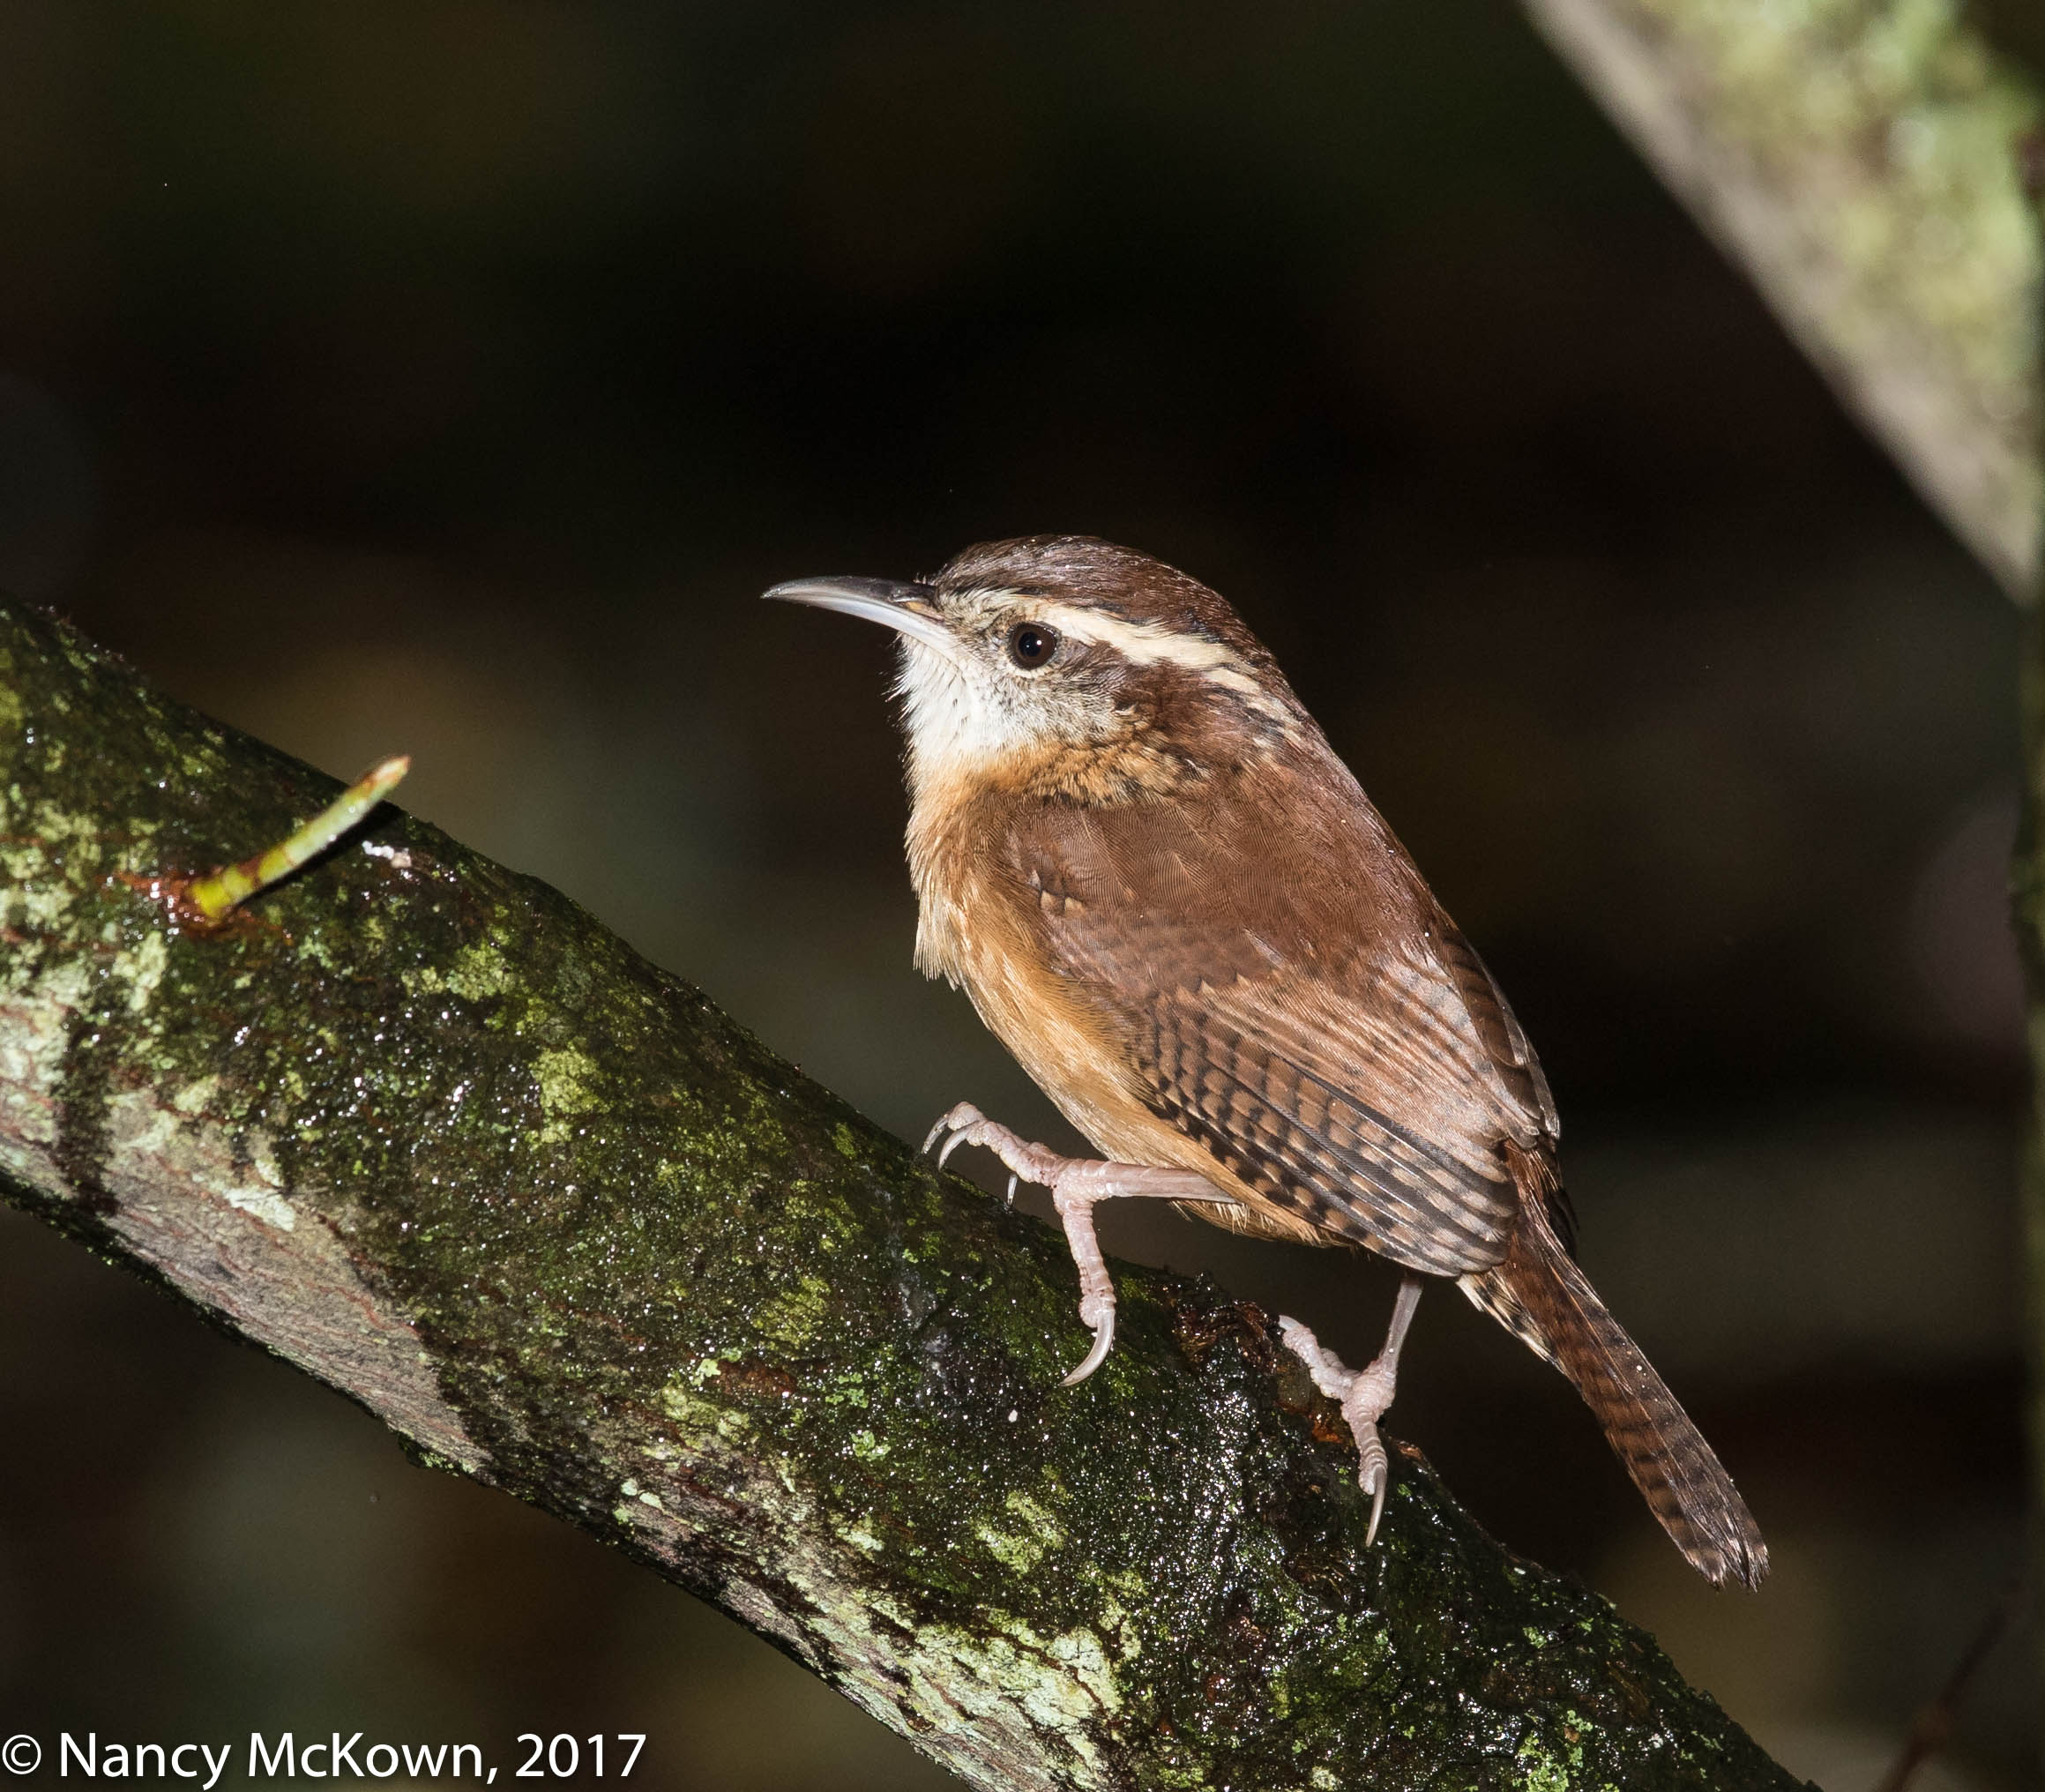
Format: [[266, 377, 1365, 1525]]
[[1011, 769, 1554, 1274]]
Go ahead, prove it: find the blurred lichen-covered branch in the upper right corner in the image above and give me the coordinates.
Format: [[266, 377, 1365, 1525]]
[[1526, 0, 2045, 603]]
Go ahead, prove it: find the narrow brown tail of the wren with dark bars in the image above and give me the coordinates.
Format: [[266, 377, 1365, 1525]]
[[1462, 1198, 1769, 1587]]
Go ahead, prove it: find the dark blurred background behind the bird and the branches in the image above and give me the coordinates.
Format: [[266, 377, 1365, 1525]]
[[0, 0, 2031, 1792]]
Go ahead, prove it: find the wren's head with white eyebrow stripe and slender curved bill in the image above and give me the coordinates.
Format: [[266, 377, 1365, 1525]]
[[767, 536, 1313, 802]]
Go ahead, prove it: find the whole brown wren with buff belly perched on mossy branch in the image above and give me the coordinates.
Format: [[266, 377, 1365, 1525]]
[[767, 536, 1767, 1586]]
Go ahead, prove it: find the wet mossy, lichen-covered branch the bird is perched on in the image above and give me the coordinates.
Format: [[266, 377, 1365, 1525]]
[[0, 608, 1794, 1792]]
